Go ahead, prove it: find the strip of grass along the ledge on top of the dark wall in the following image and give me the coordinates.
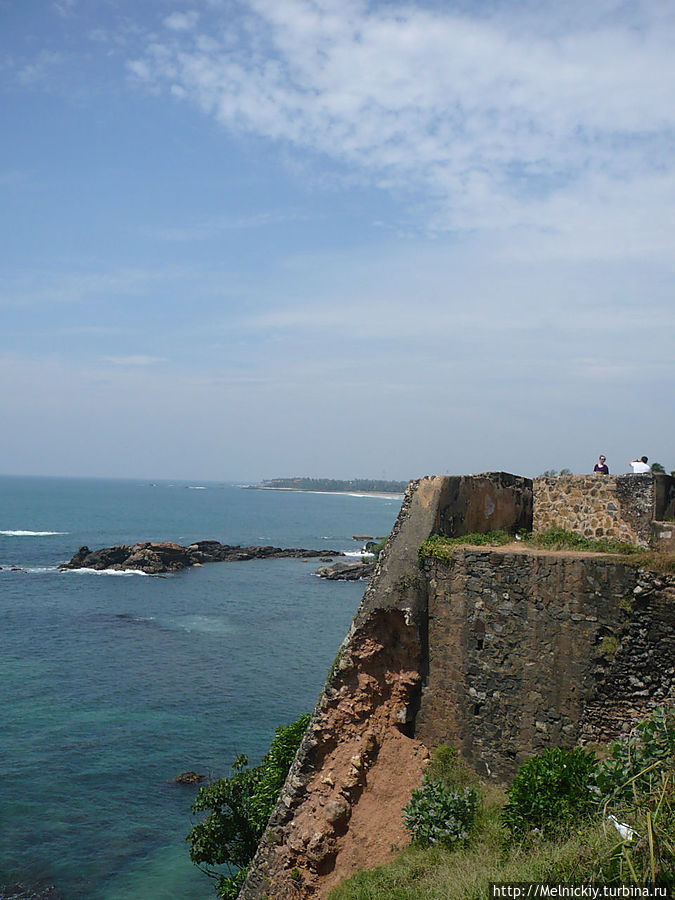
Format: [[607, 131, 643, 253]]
[[417, 528, 675, 573]]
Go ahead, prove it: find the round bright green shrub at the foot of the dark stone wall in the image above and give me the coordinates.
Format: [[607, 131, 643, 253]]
[[503, 747, 595, 837]]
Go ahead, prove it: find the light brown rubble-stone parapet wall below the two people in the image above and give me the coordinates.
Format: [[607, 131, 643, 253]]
[[533, 475, 656, 547]]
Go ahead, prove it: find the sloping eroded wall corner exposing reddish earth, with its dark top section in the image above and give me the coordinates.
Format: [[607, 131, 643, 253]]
[[239, 472, 532, 900]]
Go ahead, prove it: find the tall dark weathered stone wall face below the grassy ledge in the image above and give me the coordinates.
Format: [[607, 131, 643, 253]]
[[414, 548, 675, 777]]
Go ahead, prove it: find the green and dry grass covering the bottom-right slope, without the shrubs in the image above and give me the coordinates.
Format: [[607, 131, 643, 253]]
[[328, 758, 675, 900]]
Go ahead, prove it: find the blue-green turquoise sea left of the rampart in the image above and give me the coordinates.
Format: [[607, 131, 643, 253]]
[[0, 477, 400, 900]]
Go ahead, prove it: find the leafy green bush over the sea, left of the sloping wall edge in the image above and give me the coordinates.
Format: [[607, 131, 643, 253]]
[[186, 713, 310, 900]]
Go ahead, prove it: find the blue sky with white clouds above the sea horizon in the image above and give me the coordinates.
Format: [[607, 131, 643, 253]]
[[0, 0, 675, 481]]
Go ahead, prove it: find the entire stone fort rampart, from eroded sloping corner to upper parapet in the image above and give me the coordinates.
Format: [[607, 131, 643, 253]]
[[239, 473, 675, 900]]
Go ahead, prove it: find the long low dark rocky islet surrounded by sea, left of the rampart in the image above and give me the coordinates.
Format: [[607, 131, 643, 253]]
[[59, 541, 344, 575]]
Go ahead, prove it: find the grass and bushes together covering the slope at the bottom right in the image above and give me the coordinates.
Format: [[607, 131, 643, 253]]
[[330, 709, 675, 900]]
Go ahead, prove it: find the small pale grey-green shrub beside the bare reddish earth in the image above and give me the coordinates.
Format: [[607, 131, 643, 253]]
[[403, 777, 478, 847]]
